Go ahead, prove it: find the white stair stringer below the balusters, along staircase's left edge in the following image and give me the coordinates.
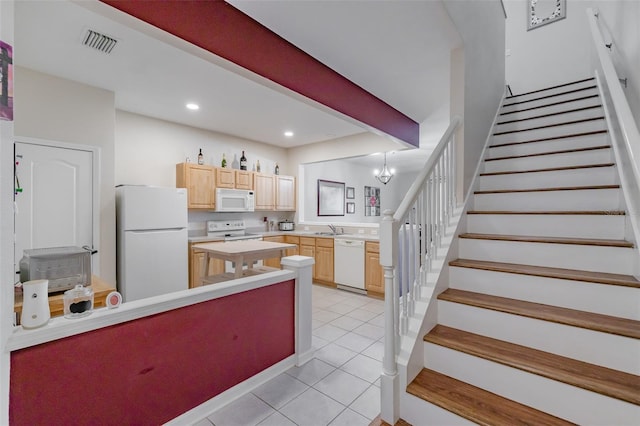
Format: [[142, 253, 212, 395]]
[[396, 93, 507, 424]]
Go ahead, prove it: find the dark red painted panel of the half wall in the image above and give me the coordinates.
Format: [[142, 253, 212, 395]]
[[9, 280, 295, 425]]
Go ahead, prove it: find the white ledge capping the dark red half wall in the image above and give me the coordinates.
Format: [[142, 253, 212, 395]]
[[6, 270, 296, 351]]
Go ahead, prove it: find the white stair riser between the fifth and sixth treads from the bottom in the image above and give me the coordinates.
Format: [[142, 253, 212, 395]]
[[467, 213, 625, 240]]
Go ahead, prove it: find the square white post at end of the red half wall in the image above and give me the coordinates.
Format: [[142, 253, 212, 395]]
[[280, 256, 315, 367]]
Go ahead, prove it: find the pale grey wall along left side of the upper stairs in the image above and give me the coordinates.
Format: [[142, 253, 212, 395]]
[[445, 0, 505, 192]]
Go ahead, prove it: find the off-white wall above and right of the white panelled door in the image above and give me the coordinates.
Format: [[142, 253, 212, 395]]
[[15, 67, 116, 283]]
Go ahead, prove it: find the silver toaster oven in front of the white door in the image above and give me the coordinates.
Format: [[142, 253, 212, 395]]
[[20, 246, 91, 293]]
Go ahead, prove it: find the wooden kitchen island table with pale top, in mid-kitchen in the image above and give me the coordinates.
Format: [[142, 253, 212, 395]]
[[193, 240, 296, 284]]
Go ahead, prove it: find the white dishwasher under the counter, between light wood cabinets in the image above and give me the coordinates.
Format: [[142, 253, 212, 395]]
[[333, 238, 365, 292]]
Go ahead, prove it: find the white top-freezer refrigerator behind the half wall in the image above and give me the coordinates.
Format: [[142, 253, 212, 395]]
[[116, 185, 189, 302]]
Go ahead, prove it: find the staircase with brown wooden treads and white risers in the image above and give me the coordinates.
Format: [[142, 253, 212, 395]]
[[401, 79, 640, 425]]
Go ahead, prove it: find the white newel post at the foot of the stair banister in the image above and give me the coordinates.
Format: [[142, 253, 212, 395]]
[[380, 210, 400, 425]]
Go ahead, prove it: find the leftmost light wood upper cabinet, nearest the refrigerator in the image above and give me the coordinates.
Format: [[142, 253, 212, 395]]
[[176, 163, 216, 209]]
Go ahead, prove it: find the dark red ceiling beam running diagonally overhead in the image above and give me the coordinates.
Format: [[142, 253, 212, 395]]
[[101, 0, 420, 147]]
